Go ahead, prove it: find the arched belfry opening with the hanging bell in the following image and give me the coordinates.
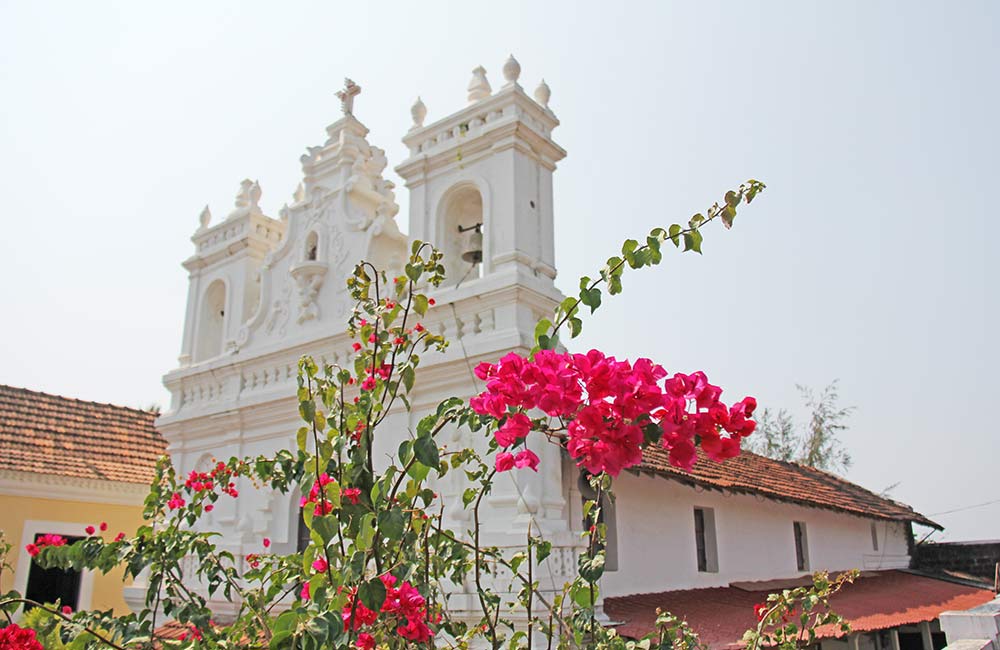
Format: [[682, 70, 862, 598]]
[[437, 183, 486, 286]]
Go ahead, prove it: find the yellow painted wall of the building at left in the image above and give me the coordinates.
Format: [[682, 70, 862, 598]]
[[0, 495, 142, 614]]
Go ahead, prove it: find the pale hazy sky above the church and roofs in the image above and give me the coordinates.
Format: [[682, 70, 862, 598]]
[[0, 0, 1000, 539]]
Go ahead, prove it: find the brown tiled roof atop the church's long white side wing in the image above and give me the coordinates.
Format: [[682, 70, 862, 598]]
[[639, 445, 942, 530]]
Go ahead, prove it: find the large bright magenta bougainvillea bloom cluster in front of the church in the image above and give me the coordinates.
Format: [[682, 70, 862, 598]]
[[469, 350, 757, 476]]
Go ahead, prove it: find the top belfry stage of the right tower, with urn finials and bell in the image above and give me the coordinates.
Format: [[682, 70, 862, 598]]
[[396, 57, 566, 290]]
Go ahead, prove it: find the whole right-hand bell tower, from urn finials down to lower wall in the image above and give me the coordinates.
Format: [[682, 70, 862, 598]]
[[396, 57, 576, 546]]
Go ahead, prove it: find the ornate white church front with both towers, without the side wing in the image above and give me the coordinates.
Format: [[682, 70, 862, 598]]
[[148, 57, 581, 618]]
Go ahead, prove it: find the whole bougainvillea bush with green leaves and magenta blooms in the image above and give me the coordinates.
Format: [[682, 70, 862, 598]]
[[0, 180, 856, 649]]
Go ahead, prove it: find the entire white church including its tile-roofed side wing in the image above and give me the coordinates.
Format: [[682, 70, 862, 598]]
[[146, 58, 992, 650]]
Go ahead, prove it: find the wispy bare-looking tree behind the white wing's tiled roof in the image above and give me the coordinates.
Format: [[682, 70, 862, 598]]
[[743, 379, 855, 473]]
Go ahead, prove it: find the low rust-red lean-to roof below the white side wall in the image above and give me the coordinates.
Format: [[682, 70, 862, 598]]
[[604, 571, 994, 648]]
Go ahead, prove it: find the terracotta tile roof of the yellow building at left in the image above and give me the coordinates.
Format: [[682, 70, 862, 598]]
[[0, 385, 166, 483]]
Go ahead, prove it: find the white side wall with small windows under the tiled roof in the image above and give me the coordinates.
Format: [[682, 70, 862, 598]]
[[602, 474, 910, 597]]
